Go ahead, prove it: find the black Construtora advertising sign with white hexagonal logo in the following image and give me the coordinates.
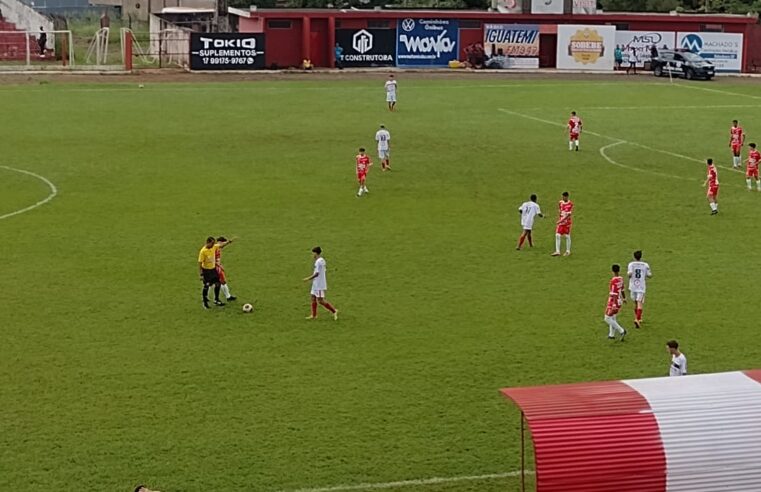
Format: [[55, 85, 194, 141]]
[[336, 29, 396, 67]]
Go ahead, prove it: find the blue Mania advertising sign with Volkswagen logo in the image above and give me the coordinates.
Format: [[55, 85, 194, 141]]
[[396, 18, 460, 67]]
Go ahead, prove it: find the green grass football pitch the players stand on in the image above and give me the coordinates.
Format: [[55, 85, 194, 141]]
[[0, 75, 761, 492]]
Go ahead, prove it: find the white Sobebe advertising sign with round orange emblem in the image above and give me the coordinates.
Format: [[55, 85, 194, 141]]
[[557, 25, 616, 71]]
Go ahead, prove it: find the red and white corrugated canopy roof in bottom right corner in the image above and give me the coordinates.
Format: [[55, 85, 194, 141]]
[[501, 370, 761, 492]]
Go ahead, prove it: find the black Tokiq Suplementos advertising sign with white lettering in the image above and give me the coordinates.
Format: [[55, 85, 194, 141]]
[[190, 32, 264, 70]]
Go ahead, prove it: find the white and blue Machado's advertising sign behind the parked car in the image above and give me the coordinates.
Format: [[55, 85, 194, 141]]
[[676, 32, 743, 73]]
